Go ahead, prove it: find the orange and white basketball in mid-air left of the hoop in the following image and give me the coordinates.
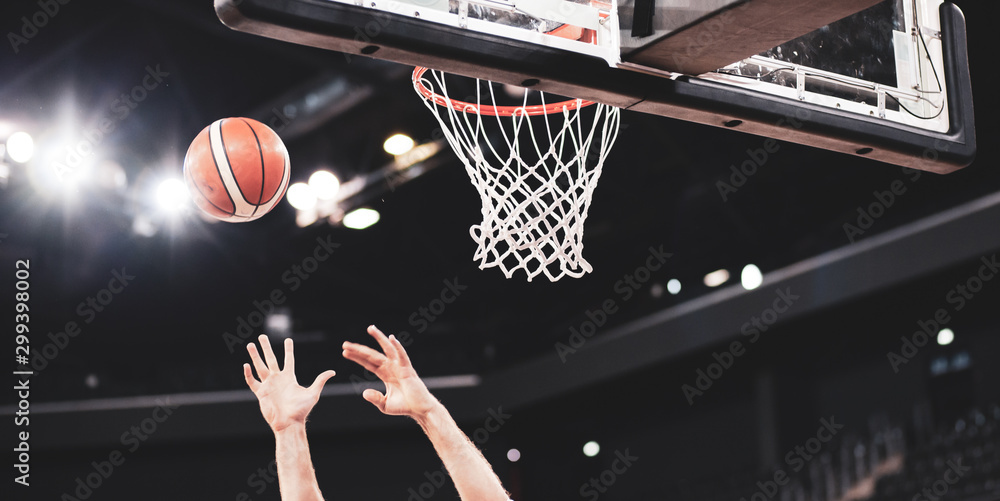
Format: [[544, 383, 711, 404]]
[[184, 118, 289, 223]]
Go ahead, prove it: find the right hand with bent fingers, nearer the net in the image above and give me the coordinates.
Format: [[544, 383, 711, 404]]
[[344, 326, 437, 417]]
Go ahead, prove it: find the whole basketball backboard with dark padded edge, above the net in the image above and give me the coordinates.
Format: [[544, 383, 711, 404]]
[[216, 0, 976, 173]]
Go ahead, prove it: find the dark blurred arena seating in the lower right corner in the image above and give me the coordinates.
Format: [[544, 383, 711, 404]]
[[668, 403, 1000, 501]]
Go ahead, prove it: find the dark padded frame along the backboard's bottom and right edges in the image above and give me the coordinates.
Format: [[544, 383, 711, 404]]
[[216, 0, 976, 173]]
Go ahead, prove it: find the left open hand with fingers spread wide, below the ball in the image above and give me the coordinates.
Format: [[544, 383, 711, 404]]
[[243, 336, 334, 431]]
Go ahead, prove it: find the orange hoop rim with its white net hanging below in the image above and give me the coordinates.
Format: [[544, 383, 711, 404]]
[[414, 70, 621, 282]]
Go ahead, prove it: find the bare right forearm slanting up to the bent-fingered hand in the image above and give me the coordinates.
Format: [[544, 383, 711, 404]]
[[417, 404, 509, 501]]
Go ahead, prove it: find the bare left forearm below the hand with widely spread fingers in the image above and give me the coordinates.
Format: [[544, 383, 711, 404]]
[[274, 424, 323, 501]]
